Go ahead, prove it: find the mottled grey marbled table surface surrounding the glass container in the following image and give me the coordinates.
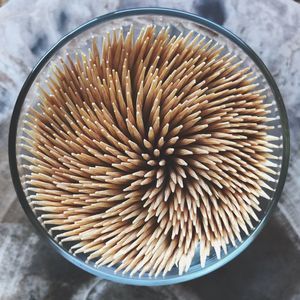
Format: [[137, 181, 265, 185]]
[[0, 0, 300, 300]]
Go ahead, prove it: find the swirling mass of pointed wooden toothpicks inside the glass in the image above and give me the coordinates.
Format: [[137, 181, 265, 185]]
[[22, 25, 277, 276]]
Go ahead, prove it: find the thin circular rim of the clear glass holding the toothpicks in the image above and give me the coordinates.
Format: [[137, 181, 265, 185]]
[[8, 7, 290, 286]]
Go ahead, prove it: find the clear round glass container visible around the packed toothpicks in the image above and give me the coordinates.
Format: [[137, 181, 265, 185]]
[[9, 8, 289, 285]]
